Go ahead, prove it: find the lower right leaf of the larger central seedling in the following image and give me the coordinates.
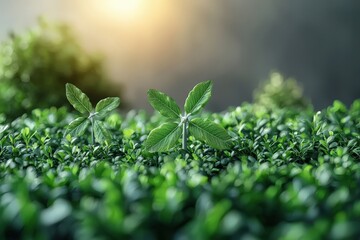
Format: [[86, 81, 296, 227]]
[[189, 118, 231, 149]]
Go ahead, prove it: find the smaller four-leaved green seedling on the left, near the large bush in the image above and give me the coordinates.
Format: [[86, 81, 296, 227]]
[[66, 83, 120, 144]]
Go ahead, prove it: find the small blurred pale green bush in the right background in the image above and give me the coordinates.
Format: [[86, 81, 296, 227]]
[[254, 72, 311, 109]]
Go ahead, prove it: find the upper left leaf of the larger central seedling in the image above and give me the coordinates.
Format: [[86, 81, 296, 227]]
[[148, 89, 181, 119]]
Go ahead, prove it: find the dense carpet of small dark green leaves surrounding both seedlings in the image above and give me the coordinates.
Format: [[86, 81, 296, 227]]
[[0, 101, 360, 240]]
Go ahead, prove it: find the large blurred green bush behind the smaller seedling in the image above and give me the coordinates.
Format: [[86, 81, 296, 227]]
[[0, 18, 121, 119]]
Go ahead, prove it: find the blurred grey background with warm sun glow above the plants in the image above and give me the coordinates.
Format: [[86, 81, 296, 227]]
[[0, 0, 360, 111]]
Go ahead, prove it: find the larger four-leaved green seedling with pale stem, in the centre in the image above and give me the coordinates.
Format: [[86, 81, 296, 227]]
[[145, 81, 231, 152]]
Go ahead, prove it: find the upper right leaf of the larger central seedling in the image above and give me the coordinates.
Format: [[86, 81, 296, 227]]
[[185, 81, 212, 115]]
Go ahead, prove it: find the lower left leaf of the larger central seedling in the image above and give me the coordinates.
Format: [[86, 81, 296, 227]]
[[144, 123, 181, 152]]
